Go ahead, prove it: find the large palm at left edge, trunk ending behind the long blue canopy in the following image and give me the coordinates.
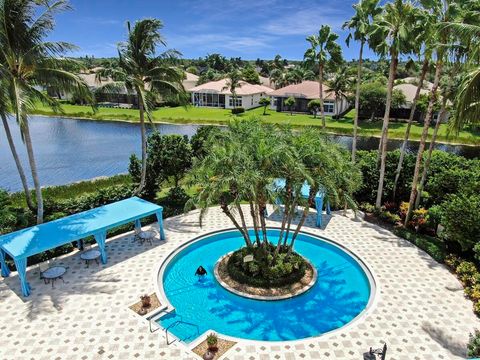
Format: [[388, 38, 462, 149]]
[[0, 0, 91, 223]]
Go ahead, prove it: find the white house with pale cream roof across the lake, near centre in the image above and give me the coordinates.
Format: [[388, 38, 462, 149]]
[[189, 79, 272, 109]]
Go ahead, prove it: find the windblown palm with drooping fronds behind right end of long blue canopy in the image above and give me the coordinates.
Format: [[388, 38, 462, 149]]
[[97, 19, 187, 193]]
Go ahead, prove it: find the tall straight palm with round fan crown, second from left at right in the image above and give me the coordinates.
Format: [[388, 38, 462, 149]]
[[371, 0, 414, 209]]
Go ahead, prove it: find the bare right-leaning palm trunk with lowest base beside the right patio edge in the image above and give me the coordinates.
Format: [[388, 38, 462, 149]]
[[405, 60, 443, 226]]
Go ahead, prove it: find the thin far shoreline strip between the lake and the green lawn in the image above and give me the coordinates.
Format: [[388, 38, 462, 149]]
[[33, 113, 480, 148]]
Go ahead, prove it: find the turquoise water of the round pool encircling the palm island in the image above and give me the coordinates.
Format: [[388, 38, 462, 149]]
[[159, 230, 371, 343]]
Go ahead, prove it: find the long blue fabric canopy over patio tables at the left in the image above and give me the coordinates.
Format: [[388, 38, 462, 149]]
[[0, 197, 165, 296]]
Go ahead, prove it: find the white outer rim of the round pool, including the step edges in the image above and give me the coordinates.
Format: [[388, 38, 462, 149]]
[[152, 226, 381, 350]]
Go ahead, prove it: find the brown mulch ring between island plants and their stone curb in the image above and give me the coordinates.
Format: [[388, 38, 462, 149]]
[[218, 255, 314, 297]]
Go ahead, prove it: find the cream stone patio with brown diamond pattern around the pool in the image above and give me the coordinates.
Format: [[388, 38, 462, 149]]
[[0, 208, 480, 360]]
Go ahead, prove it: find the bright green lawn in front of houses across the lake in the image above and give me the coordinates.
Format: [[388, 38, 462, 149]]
[[36, 104, 480, 145]]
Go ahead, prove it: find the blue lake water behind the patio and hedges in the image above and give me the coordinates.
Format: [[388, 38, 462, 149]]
[[0, 116, 480, 191]]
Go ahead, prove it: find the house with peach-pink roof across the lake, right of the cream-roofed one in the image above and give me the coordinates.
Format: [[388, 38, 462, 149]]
[[268, 80, 349, 115]]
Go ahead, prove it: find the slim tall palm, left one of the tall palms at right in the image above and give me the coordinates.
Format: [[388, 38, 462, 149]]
[[343, 0, 381, 162]]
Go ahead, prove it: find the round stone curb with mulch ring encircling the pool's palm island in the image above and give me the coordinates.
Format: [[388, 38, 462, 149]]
[[214, 251, 318, 301]]
